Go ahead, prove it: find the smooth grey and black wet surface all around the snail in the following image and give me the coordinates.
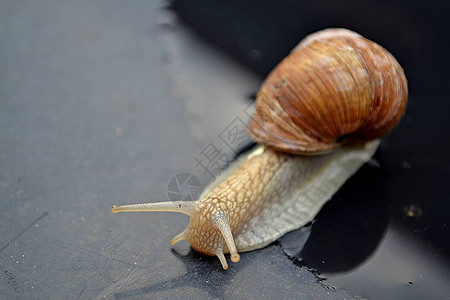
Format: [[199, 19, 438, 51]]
[[0, 0, 450, 299]]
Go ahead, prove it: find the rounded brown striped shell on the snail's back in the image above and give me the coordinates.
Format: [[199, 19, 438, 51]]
[[248, 29, 408, 154]]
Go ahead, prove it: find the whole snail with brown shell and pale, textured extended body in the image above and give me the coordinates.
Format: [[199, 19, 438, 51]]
[[111, 29, 408, 269]]
